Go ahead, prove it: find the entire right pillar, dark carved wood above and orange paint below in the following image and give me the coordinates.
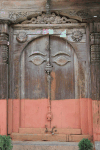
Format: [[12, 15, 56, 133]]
[[90, 23, 100, 141]]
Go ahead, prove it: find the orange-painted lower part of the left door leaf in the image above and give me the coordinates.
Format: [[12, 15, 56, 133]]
[[21, 99, 50, 128]]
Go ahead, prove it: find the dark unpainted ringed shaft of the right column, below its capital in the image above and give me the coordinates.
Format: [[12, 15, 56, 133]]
[[90, 32, 100, 100]]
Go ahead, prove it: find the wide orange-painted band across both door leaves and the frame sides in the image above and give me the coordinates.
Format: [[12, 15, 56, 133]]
[[8, 98, 93, 135]]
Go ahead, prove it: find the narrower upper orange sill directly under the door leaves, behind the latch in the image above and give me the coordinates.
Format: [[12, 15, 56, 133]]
[[19, 128, 82, 134]]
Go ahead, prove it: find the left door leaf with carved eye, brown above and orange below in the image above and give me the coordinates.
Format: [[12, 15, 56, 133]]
[[20, 36, 50, 128]]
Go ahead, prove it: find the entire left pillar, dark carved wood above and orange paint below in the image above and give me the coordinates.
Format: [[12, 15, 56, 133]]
[[0, 21, 9, 135]]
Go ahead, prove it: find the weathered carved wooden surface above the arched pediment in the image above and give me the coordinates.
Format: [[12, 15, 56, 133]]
[[0, 0, 100, 21]]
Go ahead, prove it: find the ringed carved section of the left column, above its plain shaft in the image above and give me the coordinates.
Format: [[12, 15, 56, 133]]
[[0, 33, 9, 63]]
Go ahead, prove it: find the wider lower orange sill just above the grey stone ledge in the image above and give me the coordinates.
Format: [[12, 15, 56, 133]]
[[10, 133, 92, 142]]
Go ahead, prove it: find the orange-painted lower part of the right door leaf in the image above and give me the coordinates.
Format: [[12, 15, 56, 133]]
[[51, 99, 81, 129]]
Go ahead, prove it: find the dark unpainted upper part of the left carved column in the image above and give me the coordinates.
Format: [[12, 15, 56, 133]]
[[0, 22, 9, 99]]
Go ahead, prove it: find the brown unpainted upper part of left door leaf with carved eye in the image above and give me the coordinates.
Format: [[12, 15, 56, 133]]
[[21, 36, 48, 99]]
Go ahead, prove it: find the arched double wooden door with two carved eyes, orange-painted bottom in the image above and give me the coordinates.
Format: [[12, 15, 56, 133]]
[[20, 35, 75, 128]]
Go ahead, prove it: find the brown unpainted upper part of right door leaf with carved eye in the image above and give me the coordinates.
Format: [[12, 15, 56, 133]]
[[50, 36, 75, 100]]
